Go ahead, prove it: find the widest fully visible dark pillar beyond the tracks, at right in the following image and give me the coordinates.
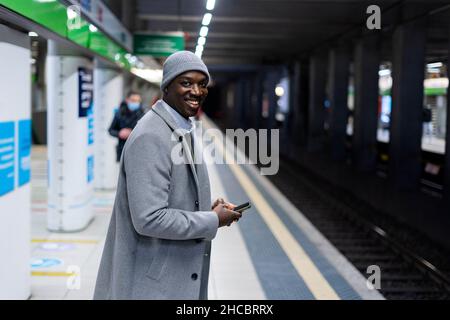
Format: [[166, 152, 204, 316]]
[[389, 20, 426, 189]]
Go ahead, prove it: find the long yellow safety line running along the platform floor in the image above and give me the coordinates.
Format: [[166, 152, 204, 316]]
[[207, 120, 340, 300]]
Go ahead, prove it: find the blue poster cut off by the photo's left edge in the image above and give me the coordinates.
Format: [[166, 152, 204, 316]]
[[0, 121, 15, 196]]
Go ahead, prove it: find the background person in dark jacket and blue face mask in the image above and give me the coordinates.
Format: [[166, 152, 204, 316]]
[[108, 91, 144, 162]]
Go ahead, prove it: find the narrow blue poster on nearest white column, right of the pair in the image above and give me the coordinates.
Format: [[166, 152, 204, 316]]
[[18, 119, 31, 186]]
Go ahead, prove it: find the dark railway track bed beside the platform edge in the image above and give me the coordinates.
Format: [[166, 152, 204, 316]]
[[269, 161, 450, 300]]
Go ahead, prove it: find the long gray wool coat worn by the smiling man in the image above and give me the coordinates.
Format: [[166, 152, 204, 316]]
[[94, 102, 219, 299]]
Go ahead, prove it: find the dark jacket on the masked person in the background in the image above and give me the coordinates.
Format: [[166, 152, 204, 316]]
[[108, 102, 144, 162]]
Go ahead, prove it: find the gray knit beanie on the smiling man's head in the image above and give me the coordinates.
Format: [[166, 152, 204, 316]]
[[161, 51, 210, 90]]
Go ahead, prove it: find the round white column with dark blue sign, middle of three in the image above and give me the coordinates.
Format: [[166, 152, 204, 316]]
[[46, 41, 94, 232]]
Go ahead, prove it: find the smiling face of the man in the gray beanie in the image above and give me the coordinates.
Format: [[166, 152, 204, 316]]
[[164, 71, 208, 118]]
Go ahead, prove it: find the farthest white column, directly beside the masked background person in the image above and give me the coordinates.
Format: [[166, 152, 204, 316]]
[[94, 68, 124, 189]]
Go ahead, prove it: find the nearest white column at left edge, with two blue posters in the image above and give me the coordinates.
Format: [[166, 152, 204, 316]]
[[0, 25, 31, 300]]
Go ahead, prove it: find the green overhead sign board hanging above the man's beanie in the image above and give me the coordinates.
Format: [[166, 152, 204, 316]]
[[133, 32, 185, 58]]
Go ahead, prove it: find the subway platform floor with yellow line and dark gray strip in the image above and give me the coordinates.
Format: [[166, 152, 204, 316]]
[[30, 123, 383, 300]]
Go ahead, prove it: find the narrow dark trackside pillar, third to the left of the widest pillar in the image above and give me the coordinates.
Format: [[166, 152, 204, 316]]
[[307, 54, 327, 151]]
